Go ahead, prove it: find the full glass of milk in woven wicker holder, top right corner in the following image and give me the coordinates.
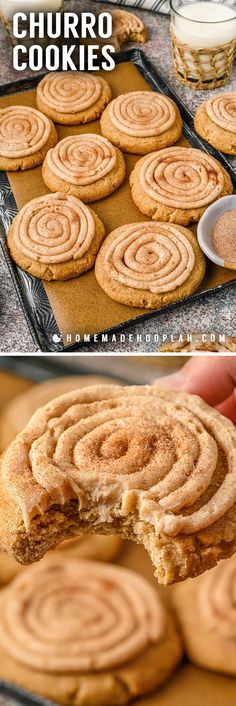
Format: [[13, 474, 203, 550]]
[[170, 0, 236, 88]]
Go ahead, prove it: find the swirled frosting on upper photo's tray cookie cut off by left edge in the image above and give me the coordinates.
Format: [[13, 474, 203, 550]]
[[0, 105, 51, 159]]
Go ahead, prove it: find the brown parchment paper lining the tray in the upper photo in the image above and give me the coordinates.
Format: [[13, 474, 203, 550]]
[[0, 62, 235, 345]]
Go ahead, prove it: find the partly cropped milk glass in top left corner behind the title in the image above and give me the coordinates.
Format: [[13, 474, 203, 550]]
[[0, 0, 64, 45]]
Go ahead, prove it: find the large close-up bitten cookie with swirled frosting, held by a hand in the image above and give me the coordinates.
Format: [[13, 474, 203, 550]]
[[0, 385, 236, 584]]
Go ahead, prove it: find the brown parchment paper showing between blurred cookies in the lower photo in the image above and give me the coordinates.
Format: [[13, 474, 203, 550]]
[[0, 370, 236, 706]]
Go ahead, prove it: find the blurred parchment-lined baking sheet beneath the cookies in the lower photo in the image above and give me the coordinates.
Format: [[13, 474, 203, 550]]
[[0, 358, 236, 706]]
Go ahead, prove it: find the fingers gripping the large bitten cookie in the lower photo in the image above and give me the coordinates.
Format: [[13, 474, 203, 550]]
[[158, 355, 236, 424]]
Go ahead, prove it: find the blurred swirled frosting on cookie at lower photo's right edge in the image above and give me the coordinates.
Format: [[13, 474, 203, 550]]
[[198, 556, 236, 641]]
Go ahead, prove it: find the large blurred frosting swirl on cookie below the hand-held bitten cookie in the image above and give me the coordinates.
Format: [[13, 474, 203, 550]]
[[0, 559, 165, 674]]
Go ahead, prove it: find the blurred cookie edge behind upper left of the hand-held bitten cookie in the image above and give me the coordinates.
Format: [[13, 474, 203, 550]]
[[0, 375, 115, 451]]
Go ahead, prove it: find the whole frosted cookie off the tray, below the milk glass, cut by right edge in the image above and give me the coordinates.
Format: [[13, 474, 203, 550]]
[[194, 93, 236, 154]]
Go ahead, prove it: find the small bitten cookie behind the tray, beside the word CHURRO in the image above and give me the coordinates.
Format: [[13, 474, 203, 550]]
[[109, 10, 148, 51]]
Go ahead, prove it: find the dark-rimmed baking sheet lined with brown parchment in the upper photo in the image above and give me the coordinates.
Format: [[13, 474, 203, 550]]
[[0, 50, 236, 351]]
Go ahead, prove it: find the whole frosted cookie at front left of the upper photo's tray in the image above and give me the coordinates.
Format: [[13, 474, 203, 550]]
[[7, 193, 105, 281]]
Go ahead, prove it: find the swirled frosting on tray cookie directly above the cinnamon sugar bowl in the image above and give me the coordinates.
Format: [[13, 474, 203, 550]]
[[139, 147, 224, 209]]
